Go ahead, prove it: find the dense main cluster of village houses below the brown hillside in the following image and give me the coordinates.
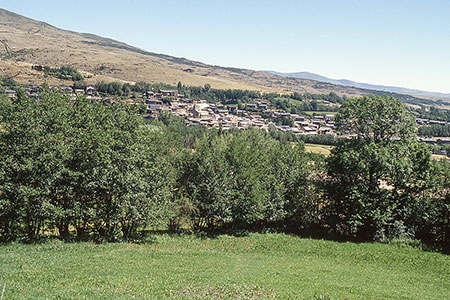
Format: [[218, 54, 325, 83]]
[[144, 90, 335, 135]]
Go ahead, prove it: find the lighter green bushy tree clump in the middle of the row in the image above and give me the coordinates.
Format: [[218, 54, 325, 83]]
[[185, 129, 309, 229]]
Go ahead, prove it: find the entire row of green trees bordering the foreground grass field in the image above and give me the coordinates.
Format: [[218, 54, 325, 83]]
[[0, 90, 450, 250]]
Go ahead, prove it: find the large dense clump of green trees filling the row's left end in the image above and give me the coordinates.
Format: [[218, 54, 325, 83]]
[[0, 89, 175, 240]]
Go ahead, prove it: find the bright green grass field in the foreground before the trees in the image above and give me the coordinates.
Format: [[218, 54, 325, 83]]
[[0, 234, 450, 300]]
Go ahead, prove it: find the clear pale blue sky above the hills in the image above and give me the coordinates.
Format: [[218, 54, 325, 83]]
[[0, 0, 450, 93]]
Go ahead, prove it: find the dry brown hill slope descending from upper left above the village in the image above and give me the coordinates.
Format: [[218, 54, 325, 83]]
[[0, 9, 365, 96]]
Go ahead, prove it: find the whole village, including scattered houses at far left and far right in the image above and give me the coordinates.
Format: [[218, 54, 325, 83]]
[[0, 85, 450, 144]]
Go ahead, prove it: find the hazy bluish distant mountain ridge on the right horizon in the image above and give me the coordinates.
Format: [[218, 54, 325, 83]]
[[263, 71, 450, 99]]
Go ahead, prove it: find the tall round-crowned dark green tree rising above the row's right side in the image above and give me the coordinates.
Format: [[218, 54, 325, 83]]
[[325, 96, 430, 239]]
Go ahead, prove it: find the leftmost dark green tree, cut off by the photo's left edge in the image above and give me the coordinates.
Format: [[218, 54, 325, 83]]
[[0, 91, 54, 240]]
